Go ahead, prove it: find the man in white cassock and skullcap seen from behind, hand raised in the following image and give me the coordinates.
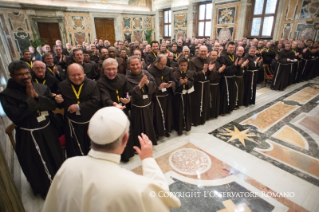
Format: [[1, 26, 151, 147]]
[[43, 107, 181, 212]]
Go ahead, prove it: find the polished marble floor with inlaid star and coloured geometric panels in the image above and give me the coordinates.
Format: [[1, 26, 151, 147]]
[[21, 78, 319, 212]]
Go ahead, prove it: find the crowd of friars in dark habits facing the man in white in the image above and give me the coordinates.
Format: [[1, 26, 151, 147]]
[[0, 35, 318, 198]]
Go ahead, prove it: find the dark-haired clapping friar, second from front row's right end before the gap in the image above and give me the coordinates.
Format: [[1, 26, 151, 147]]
[[219, 41, 240, 115]]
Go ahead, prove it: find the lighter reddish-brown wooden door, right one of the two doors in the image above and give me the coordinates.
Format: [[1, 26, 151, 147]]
[[94, 18, 115, 46]]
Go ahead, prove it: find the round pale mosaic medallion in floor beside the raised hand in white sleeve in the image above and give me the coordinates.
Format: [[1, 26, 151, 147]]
[[169, 148, 212, 175]]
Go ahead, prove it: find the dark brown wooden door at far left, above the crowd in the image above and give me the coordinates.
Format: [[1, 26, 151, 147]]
[[38, 22, 61, 51]]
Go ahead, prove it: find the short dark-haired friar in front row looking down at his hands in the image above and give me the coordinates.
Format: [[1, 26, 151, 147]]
[[174, 57, 194, 135]]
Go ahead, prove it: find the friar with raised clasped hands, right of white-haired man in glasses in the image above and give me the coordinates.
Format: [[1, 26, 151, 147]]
[[125, 56, 157, 147]]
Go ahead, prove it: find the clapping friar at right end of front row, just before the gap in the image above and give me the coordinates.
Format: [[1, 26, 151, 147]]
[[242, 46, 262, 107]]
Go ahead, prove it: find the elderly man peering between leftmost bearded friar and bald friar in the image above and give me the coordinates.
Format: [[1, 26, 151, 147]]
[[32, 61, 59, 94]]
